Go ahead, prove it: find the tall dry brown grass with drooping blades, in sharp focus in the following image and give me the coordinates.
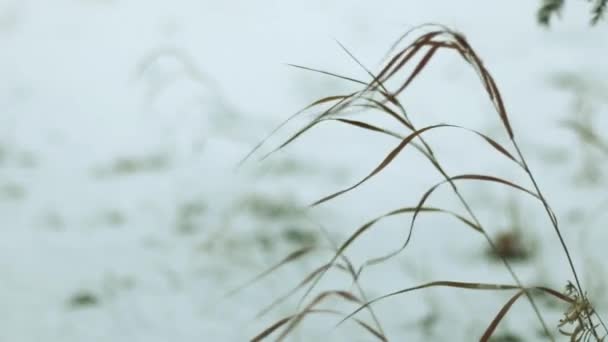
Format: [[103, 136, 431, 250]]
[[238, 25, 608, 341]]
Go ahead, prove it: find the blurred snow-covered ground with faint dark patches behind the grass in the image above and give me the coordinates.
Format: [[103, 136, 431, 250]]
[[0, 0, 608, 342]]
